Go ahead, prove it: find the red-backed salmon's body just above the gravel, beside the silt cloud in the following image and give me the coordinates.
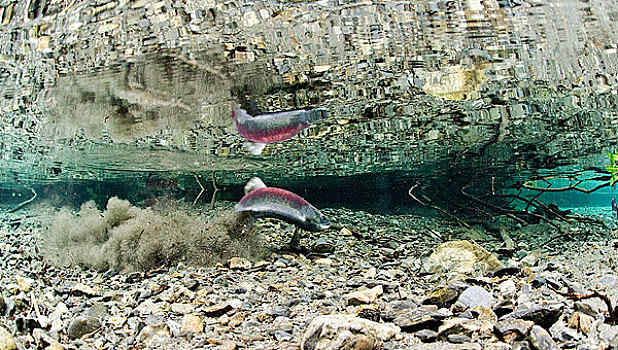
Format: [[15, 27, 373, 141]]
[[236, 187, 330, 231]]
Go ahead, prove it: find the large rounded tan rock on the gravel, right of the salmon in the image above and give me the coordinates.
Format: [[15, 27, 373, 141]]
[[423, 241, 502, 274]]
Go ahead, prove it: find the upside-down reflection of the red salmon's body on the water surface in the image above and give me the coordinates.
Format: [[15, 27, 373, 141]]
[[232, 108, 327, 144]]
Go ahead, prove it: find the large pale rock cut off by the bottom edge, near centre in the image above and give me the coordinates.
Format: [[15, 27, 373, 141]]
[[301, 315, 400, 350]]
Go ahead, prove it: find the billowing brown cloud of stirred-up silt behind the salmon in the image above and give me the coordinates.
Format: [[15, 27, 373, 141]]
[[40, 197, 264, 271]]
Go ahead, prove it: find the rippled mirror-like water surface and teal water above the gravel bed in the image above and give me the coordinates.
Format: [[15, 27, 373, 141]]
[[0, 0, 618, 219]]
